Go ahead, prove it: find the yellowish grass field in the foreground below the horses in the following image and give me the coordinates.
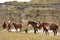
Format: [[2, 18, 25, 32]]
[[0, 32, 60, 40]]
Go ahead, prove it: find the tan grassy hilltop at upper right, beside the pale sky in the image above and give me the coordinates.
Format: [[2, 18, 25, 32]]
[[31, 0, 60, 4]]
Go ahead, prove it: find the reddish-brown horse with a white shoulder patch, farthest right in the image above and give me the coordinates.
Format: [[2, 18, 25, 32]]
[[42, 23, 58, 35]]
